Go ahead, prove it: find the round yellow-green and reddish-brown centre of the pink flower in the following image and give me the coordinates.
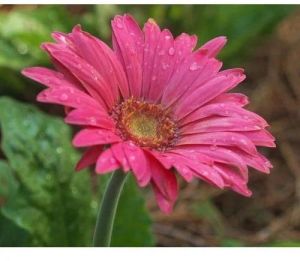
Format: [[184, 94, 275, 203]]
[[112, 98, 177, 150]]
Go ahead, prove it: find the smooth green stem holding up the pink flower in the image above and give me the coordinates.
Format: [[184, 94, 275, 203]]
[[93, 169, 128, 247]]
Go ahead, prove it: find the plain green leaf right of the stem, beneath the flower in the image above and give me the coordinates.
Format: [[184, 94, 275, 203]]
[[100, 174, 154, 247]]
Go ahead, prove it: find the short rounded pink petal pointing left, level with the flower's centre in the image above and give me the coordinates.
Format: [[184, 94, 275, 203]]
[[65, 108, 115, 130]]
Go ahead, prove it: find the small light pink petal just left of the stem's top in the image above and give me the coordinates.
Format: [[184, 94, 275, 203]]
[[96, 148, 120, 175]]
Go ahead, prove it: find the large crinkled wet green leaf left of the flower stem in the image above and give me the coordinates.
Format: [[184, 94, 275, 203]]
[[0, 97, 93, 246]]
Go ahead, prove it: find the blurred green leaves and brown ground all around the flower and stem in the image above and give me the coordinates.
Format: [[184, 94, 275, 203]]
[[0, 5, 300, 246]]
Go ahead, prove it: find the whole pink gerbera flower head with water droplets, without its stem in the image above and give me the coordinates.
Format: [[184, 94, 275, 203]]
[[23, 15, 275, 213]]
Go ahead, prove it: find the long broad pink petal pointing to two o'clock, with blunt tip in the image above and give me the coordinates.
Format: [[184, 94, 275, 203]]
[[174, 69, 245, 119]]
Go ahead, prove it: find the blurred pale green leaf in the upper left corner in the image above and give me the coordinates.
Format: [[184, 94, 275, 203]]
[[0, 6, 73, 70]]
